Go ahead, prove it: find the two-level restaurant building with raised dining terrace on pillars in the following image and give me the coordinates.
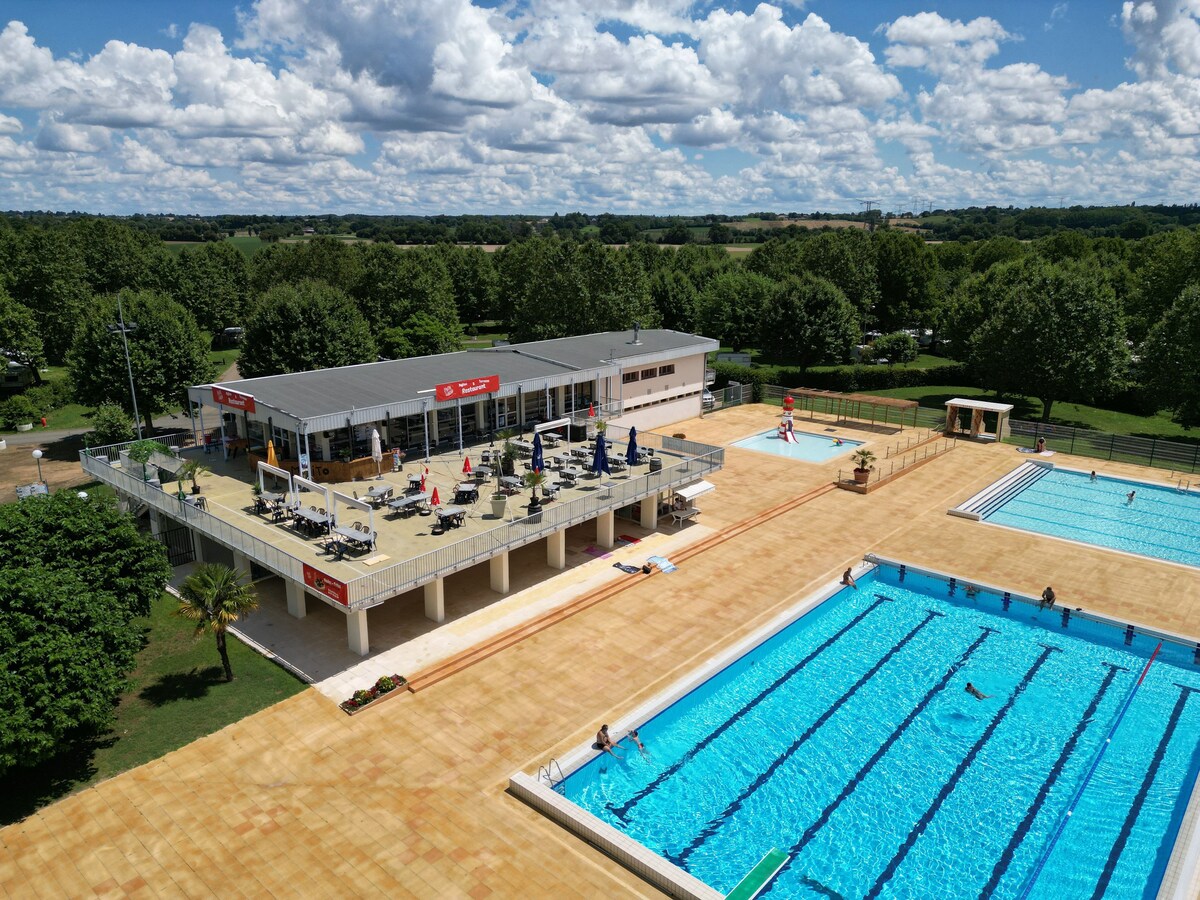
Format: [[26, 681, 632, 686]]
[[80, 330, 724, 655]]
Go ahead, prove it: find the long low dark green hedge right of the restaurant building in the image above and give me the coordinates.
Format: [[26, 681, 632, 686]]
[[710, 362, 978, 401]]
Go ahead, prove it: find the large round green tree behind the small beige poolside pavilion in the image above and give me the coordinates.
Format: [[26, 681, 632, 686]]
[[970, 257, 1129, 421]]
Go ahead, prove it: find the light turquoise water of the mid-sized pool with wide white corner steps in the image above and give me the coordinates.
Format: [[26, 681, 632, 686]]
[[985, 469, 1200, 566]]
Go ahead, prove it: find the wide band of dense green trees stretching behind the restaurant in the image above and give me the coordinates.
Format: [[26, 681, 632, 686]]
[[0, 218, 1200, 425]]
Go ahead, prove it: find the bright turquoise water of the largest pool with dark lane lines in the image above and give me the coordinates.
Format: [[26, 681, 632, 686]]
[[559, 568, 1200, 900]]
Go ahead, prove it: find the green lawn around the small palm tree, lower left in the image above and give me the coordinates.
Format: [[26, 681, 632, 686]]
[[0, 594, 305, 824]]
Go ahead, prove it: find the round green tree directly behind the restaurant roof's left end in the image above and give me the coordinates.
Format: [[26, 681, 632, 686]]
[[238, 281, 376, 378]]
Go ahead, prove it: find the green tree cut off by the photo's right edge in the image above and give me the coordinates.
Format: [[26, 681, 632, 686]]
[[1141, 284, 1200, 428]]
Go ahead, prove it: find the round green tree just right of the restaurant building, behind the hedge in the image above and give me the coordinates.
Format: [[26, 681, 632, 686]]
[[760, 274, 859, 368]]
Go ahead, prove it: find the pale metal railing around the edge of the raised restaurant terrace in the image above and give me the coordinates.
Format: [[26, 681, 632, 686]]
[[79, 427, 725, 610]]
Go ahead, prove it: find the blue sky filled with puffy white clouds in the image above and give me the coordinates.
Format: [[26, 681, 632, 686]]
[[0, 0, 1200, 214]]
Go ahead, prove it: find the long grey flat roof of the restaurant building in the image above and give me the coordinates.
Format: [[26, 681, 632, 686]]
[[190, 329, 718, 421]]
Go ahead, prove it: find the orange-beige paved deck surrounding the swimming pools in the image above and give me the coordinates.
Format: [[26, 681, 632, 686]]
[[0, 407, 1200, 898]]
